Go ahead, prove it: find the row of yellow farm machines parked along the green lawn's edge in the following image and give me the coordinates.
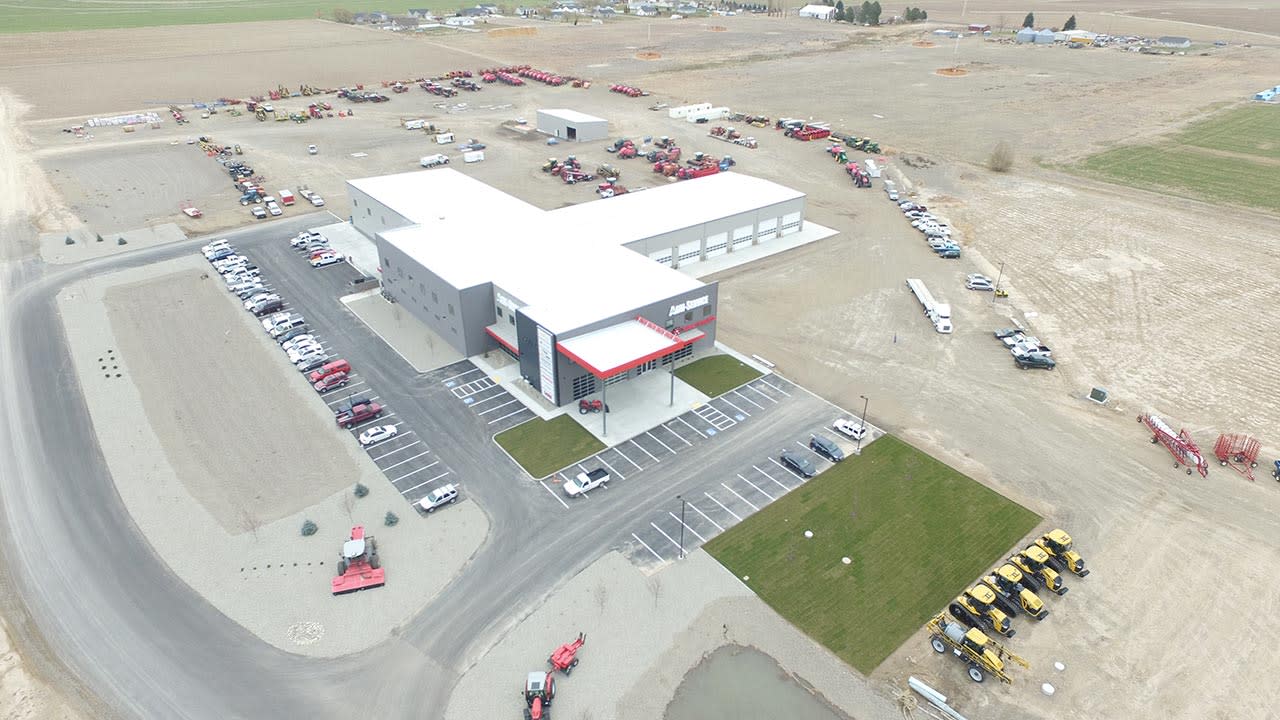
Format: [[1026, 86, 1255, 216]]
[[927, 529, 1089, 683]]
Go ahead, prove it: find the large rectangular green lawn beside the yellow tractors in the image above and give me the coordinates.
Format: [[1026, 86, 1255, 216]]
[[704, 436, 1041, 674]]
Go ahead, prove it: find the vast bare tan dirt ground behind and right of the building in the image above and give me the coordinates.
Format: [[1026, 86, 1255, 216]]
[[0, 9, 1280, 719]]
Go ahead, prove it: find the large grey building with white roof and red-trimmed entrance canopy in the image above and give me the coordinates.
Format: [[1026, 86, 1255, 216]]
[[347, 169, 805, 405]]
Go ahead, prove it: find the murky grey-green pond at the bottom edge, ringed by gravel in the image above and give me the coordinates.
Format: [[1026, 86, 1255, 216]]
[[664, 646, 851, 720]]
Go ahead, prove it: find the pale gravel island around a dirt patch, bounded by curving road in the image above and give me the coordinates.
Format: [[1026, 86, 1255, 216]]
[[59, 256, 488, 656]]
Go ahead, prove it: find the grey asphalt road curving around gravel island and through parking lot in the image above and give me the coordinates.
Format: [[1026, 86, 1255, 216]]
[[0, 215, 829, 719]]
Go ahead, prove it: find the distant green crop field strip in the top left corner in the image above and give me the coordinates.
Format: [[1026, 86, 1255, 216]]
[[0, 0, 445, 33]]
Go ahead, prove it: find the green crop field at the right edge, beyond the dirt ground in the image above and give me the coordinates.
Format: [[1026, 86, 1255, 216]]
[[1073, 105, 1280, 213]]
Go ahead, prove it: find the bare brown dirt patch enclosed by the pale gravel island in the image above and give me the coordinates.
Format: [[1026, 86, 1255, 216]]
[[106, 270, 360, 534]]
